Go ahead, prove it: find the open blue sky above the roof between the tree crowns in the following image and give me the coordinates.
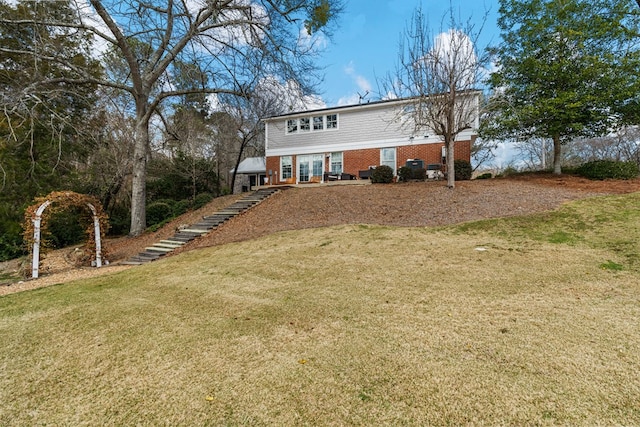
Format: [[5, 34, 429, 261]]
[[318, 0, 499, 107]]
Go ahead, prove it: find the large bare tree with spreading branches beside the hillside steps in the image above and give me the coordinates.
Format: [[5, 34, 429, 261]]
[[0, 0, 340, 235]]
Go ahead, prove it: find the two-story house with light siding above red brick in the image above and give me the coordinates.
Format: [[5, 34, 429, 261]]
[[264, 92, 479, 185]]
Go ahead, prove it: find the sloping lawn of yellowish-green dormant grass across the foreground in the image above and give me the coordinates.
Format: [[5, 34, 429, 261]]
[[0, 194, 640, 426]]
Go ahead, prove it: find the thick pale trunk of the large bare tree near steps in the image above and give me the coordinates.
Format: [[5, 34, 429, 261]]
[[129, 113, 149, 236]]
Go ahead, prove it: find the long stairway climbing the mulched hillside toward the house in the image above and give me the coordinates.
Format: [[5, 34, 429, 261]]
[[120, 188, 280, 265]]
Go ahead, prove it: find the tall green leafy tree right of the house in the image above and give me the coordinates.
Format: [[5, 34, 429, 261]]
[[481, 0, 640, 174]]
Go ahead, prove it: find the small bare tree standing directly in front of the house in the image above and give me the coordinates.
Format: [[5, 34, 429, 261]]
[[383, 9, 488, 188]]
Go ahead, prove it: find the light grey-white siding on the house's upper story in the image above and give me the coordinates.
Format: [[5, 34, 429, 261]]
[[265, 94, 478, 157]]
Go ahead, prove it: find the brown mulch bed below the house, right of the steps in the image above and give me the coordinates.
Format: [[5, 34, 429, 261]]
[[175, 175, 640, 254]]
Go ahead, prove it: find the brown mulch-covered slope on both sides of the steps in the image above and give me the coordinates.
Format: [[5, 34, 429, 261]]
[[5, 175, 640, 295]]
